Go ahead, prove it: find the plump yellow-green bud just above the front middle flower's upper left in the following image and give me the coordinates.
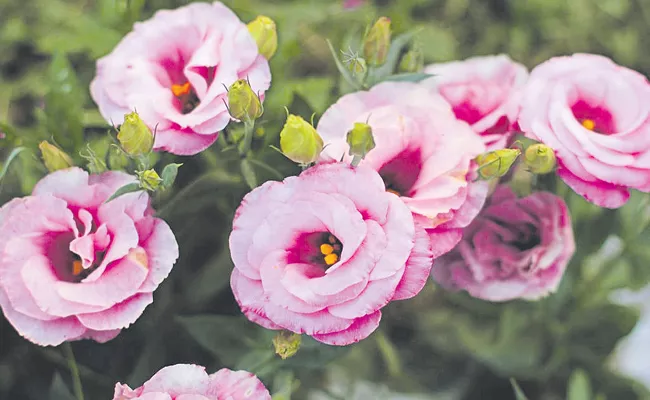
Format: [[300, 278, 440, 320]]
[[280, 114, 323, 165]]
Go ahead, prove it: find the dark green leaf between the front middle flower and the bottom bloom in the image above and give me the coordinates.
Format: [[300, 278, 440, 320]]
[[176, 315, 260, 365]]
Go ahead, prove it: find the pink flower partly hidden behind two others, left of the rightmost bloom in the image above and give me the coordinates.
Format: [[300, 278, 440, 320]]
[[424, 54, 528, 150]]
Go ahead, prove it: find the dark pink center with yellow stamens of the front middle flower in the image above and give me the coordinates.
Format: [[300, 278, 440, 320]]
[[287, 232, 343, 270]]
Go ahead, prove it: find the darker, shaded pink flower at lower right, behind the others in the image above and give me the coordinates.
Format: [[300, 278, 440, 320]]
[[433, 185, 575, 301]]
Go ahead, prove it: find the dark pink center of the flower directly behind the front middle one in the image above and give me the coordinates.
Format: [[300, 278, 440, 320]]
[[379, 149, 422, 197]]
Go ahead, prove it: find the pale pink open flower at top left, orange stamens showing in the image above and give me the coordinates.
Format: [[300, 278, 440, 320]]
[[90, 2, 271, 155]]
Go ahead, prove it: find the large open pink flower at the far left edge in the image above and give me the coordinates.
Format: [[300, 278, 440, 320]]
[[0, 167, 178, 346]]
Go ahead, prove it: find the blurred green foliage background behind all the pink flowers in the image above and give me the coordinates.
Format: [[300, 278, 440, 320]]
[[0, 0, 650, 400]]
